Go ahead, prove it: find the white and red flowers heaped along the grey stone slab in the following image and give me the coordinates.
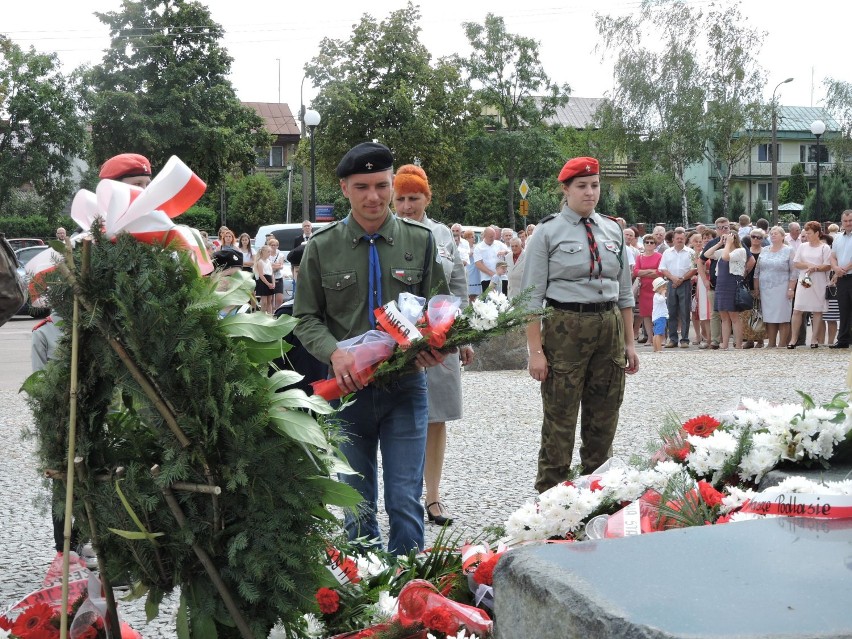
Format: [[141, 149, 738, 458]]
[[505, 393, 852, 544]]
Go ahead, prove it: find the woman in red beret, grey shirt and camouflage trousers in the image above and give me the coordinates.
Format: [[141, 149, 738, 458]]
[[522, 157, 639, 492]]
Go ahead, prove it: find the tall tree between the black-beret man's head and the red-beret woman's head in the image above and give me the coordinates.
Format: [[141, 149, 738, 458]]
[[458, 13, 571, 228]]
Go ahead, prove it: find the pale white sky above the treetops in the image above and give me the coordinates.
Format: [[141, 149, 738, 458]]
[[6, 0, 852, 114]]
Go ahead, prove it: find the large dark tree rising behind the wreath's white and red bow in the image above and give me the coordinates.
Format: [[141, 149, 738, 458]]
[[85, 0, 271, 191]]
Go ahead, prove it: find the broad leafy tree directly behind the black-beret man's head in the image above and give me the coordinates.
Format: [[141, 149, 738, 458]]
[[305, 2, 473, 208]]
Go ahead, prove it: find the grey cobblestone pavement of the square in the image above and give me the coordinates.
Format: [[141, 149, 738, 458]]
[[0, 331, 850, 639]]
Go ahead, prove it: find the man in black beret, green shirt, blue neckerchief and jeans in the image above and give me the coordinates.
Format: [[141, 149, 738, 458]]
[[293, 142, 449, 554]]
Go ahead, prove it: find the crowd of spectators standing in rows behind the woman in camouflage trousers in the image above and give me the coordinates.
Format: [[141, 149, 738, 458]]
[[624, 210, 852, 350]]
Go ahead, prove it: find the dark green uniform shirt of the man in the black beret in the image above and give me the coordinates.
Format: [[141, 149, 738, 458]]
[[293, 209, 449, 362]]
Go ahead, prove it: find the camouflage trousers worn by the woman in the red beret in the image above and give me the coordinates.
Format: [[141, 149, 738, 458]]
[[535, 308, 627, 492]]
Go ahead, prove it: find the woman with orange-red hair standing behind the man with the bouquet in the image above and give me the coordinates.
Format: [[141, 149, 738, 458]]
[[393, 164, 473, 526]]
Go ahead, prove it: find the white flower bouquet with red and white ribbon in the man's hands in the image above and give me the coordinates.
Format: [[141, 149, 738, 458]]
[[312, 289, 546, 401]]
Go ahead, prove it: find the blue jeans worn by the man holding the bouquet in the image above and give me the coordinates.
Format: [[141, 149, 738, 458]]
[[332, 371, 429, 555]]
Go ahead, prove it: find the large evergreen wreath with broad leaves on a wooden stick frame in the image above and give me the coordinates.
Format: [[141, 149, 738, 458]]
[[26, 229, 355, 639]]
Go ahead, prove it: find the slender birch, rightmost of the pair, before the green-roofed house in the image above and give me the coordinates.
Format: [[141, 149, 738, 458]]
[[702, 4, 771, 217]]
